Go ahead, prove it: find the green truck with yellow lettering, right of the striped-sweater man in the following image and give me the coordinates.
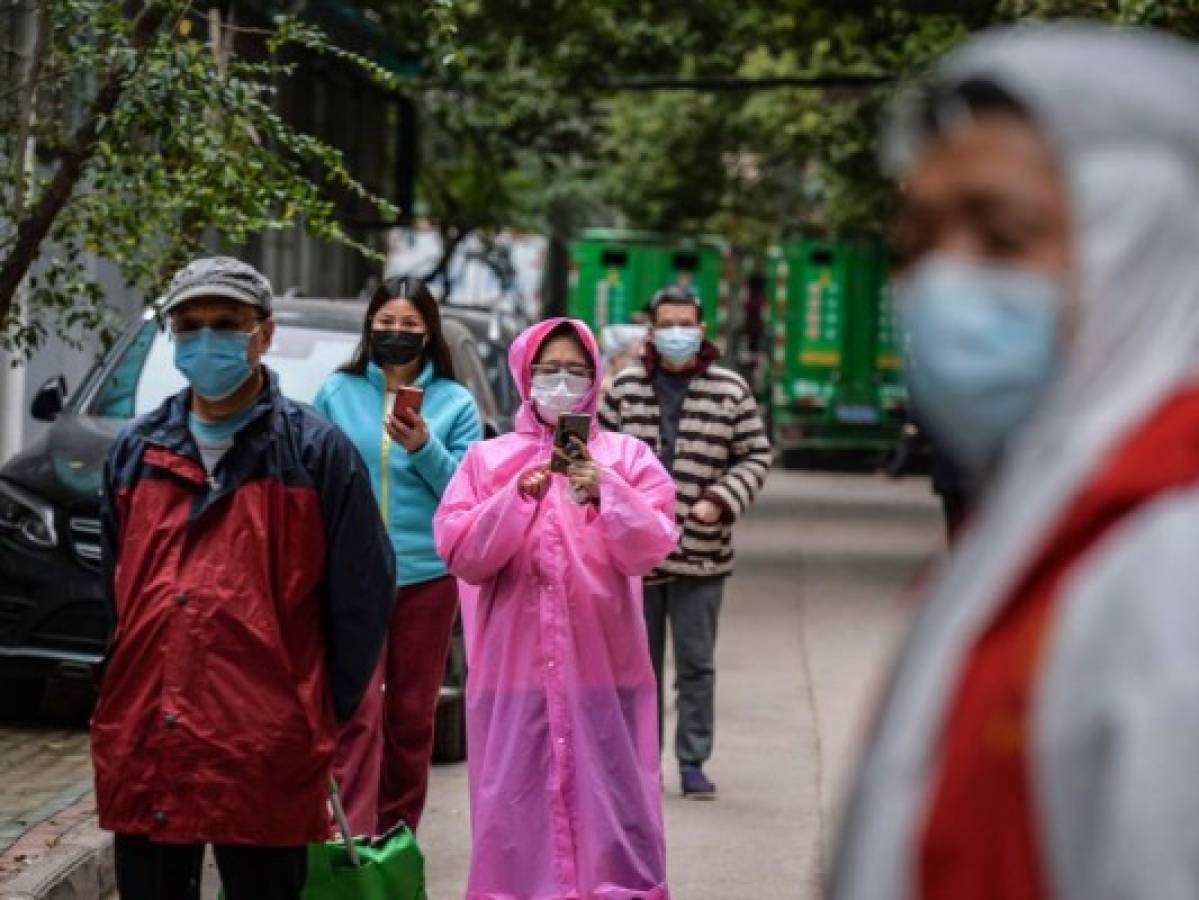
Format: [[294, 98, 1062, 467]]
[[763, 238, 908, 464]]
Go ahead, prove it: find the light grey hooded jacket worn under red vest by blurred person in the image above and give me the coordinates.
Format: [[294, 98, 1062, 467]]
[[831, 24, 1199, 900]]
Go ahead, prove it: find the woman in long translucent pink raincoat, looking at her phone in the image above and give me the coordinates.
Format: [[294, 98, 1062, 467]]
[[434, 319, 677, 900]]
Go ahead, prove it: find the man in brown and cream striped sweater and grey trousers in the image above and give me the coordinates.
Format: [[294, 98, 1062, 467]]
[[598, 286, 771, 799]]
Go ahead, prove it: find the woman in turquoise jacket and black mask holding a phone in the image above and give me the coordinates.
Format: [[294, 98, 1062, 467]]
[[315, 277, 482, 834]]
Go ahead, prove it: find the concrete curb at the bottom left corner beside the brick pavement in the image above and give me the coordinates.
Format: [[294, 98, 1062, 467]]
[[0, 821, 116, 900]]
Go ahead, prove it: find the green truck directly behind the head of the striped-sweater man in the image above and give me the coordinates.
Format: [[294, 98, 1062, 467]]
[[566, 228, 733, 348]]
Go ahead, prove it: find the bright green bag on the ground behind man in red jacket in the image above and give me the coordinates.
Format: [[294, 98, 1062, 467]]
[[303, 826, 427, 900]]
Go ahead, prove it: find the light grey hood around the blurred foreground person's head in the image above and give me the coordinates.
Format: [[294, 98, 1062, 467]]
[[887, 23, 1199, 469]]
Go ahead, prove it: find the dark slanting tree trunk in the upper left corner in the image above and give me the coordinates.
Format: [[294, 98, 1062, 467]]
[[0, 2, 168, 324]]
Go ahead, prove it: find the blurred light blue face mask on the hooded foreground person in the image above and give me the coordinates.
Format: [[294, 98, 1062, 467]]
[[896, 256, 1065, 471]]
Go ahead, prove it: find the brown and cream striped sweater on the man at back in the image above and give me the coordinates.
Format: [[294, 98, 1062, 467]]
[[598, 350, 772, 580]]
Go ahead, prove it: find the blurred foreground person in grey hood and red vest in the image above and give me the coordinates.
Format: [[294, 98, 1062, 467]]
[[832, 24, 1199, 900]]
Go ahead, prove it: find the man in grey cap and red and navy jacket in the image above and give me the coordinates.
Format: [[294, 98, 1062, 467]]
[[91, 258, 394, 900]]
